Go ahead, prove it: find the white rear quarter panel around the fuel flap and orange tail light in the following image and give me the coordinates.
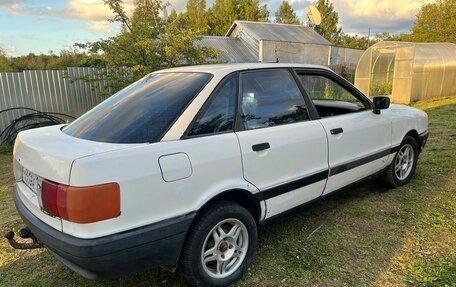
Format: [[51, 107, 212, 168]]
[[67, 133, 257, 238]]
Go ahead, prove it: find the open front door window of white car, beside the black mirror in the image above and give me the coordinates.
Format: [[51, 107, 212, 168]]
[[298, 73, 367, 118]]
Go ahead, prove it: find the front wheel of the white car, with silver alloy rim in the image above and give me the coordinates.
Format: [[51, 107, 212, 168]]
[[385, 136, 418, 188]]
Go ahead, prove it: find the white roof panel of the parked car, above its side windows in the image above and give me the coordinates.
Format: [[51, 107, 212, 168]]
[[156, 63, 330, 75]]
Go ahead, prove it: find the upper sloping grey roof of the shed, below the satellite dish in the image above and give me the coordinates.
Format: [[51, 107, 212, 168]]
[[226, 21, 332, 45]]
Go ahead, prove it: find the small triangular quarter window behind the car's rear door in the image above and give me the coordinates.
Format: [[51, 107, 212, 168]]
[[187, 74, 237, 136]]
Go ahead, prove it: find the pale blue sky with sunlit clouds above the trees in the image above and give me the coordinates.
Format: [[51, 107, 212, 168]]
[[0, 0, 435, 56]]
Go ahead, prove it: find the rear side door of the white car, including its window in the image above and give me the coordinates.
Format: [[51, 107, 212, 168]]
[[236, 69, 328, 218]]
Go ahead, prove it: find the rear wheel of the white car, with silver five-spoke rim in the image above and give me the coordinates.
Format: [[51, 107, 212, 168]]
[[181, 201, 258, 286]]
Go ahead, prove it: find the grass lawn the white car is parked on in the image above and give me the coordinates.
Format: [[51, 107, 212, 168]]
[[0, 97, 456, 286]]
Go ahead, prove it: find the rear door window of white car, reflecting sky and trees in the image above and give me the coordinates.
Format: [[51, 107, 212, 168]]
[[240, 70, 310, 129]]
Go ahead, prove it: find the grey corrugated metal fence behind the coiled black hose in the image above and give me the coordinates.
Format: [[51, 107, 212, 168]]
[[0, 68, 103, 131]]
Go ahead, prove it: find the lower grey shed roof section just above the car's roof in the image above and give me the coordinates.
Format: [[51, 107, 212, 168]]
[[196, 36, 258, 63]]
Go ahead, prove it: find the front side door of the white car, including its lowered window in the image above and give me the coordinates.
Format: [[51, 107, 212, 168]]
[[297, 71, 393, 194]]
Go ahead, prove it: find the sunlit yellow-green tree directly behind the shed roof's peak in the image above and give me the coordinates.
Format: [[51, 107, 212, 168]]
[[207, 0, 269, 36]]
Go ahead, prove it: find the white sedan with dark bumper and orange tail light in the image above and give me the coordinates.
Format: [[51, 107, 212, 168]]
[[9, 63, 428, 286]]
